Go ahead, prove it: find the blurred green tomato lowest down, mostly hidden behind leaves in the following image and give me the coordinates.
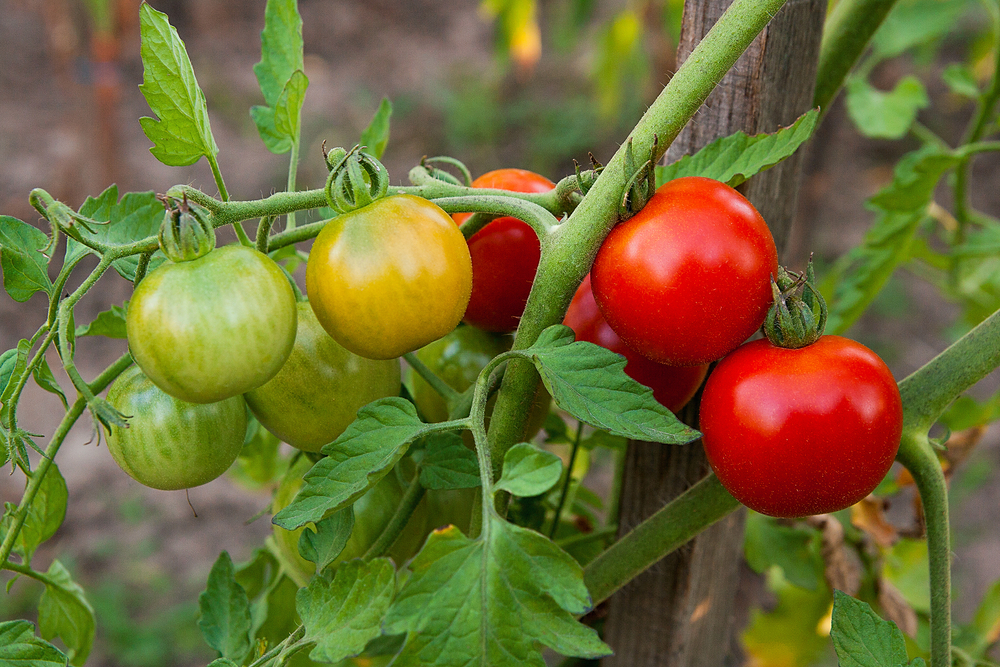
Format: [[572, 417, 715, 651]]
[[271, 457, 428, 584]]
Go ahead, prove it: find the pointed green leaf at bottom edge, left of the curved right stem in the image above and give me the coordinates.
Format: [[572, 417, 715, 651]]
[[830, 591, 909, 667]]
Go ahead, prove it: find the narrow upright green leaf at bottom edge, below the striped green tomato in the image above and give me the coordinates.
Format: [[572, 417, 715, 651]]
[[198, 551, 250, 664]]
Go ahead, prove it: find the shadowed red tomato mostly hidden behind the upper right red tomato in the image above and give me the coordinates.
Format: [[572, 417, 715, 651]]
[[563, 274, 708, 412]]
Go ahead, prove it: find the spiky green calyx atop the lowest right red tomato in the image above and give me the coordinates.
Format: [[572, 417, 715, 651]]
[[763, 259, 827, 350]]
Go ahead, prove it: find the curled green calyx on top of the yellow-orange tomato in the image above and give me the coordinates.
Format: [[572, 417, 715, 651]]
[[323, 144, 389, 213]]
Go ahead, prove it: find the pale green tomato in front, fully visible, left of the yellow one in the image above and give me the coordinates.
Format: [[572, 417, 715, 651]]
[[126, 245, 296, 403]]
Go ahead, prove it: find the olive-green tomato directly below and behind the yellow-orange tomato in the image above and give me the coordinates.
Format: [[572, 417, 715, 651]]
[[244, 302, 400, 452]]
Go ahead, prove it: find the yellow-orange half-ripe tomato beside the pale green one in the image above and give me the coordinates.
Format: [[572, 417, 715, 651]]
[[306, 195, 472, 359]]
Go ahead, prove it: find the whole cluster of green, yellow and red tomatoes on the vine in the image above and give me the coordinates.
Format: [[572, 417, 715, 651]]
[[108, 169, 901, 516]]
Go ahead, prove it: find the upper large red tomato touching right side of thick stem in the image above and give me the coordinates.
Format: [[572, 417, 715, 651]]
[[591, 177, 778, 366]]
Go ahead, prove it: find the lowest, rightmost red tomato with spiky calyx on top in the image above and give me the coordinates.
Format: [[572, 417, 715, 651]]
[[700, 336, 903, 518]]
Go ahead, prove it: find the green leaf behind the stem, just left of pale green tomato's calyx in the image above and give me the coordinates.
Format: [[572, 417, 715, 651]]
[[66, 187, 166, 281]]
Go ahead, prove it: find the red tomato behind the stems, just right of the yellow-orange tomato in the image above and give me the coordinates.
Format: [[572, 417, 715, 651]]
[[454, 169, 555, 333]]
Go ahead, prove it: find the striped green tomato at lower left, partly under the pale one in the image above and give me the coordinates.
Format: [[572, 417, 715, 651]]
[[108, 366, 247, 490]]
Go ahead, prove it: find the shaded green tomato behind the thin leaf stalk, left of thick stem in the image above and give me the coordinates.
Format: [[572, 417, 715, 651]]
[[408, 326, 552, 438]]
